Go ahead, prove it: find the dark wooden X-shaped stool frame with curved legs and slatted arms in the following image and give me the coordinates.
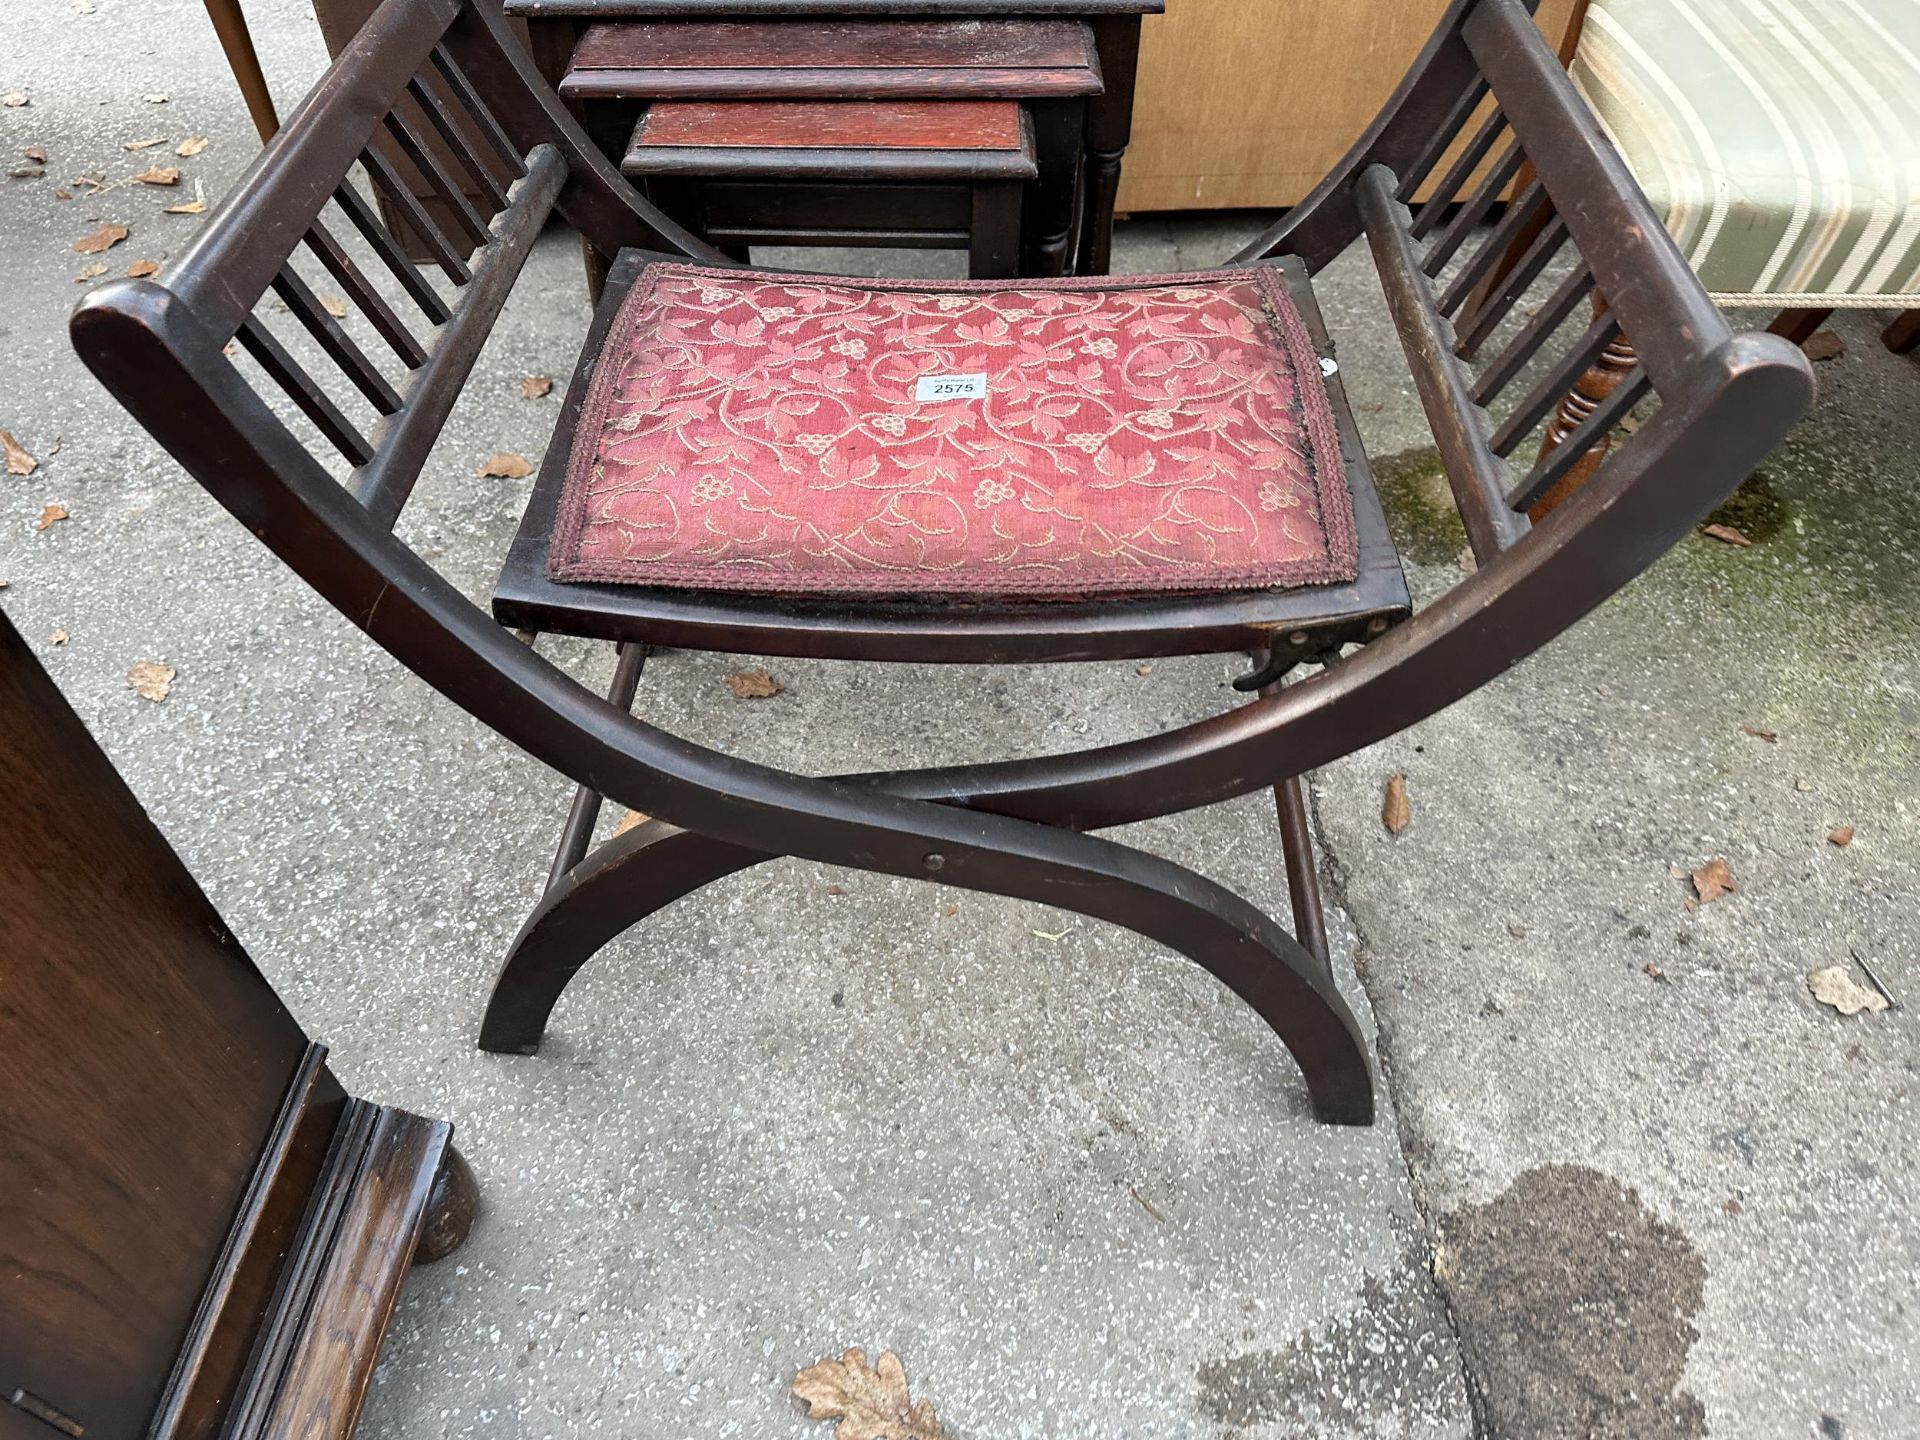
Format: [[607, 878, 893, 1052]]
[[73, 0, 1812, 1123]]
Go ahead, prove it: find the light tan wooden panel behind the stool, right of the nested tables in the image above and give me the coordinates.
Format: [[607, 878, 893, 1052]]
[[1119, 0, 1574, 211]]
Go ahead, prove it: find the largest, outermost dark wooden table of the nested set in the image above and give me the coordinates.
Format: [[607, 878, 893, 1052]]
[[507, 0, 1165, 275]]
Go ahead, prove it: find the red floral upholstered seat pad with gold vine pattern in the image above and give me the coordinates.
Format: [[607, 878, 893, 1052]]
[[549, 265, 1356, 599]]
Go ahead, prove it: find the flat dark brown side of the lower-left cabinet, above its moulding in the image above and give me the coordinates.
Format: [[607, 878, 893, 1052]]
[[0, 622, 307, 1438]]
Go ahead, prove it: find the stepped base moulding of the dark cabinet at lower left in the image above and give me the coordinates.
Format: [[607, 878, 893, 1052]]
[[148, 1067, 453, 1440]]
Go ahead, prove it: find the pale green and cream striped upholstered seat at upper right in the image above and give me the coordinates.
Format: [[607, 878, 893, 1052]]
[[1572, 0, 1920, 307]]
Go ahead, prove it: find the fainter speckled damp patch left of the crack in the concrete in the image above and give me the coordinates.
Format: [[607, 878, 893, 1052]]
[[1198, 1271, 1459, 1438]]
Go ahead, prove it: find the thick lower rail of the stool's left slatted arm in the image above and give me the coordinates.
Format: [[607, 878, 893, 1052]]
[[355, 144, 566, 526]]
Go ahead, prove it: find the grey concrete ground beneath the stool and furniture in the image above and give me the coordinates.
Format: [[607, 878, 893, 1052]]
[[0, 0, 1920, 1440]]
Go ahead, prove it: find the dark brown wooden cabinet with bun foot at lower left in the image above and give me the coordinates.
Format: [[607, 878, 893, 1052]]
[[0, 614, 472, 1440]]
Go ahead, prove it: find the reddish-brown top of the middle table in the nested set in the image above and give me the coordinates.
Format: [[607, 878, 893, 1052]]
[[561, 19, 1102, 100]]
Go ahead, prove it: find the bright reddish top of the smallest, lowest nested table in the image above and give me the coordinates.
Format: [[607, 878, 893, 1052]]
[[634, 100, 1025, 152]]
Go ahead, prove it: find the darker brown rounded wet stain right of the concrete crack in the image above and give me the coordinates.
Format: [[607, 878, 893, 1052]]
[[1434, 1165, 1707, 1440]]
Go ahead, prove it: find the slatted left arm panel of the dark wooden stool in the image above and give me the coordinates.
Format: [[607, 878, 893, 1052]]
[[175, 0, 568, 528]]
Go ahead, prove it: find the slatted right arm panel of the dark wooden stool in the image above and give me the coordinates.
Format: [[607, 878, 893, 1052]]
[[1356, 0, 1728, 561]]
